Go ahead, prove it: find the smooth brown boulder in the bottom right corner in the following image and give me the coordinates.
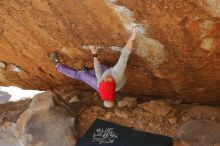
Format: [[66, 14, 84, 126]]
[[177, 120, 220, 146]]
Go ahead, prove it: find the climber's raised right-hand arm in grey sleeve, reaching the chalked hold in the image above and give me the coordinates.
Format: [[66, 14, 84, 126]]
[[112, 28, 137, 77]]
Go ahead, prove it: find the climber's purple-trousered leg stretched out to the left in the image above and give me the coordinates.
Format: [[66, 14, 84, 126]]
[[56, 63, 98, 90]]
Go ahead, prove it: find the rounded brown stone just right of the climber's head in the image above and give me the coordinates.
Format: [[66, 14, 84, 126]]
[[118, 97, 137, 108]]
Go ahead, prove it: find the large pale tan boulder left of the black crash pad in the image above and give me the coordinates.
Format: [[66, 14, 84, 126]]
[[17, 91, 76, 146]]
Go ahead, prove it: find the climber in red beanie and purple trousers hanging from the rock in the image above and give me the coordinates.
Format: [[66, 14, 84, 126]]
[[50, 27, 138, 108]]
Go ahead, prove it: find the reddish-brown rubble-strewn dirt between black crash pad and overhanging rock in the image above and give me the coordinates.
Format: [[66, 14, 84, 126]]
[[67, 90, 220, 146]]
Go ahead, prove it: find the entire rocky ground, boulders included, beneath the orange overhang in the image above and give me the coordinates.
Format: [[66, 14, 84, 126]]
[[0, 91, 220, 146]]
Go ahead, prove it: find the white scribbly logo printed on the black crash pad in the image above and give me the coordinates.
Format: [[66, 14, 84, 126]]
[[92, 128, 118, 144]]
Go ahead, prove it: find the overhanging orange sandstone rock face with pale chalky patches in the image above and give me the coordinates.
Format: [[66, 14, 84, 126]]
[[0, 0, 220, 103]]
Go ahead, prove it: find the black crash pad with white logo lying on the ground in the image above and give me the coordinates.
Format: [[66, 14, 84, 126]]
[[77, 119, 172, 146]]
